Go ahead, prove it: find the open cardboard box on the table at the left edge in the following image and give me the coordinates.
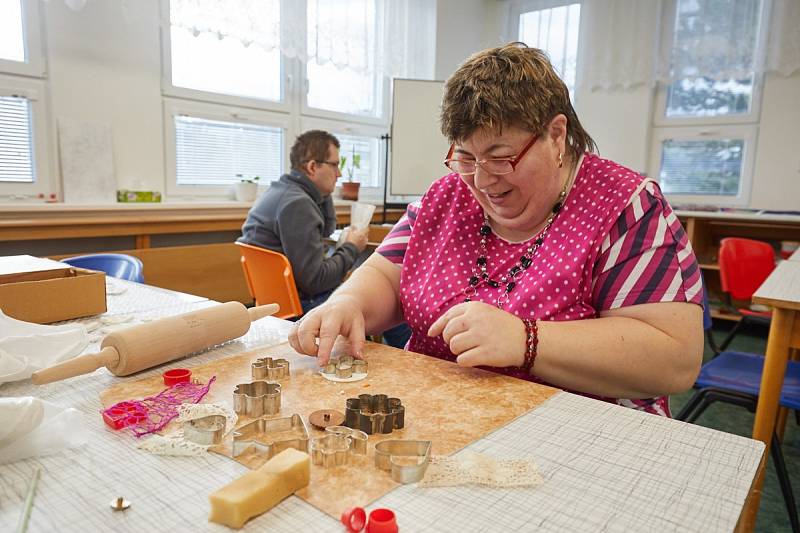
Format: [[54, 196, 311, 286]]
[[0, 255, 106, 324]]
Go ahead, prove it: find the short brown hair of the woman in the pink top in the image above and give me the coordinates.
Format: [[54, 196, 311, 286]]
[[441, 43, 597, 161]]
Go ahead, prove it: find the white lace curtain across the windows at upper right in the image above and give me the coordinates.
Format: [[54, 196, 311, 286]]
[[508, 0, 800, 90]]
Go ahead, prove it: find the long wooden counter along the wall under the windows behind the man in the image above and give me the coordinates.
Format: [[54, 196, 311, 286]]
[[0, 202, 404, 303]]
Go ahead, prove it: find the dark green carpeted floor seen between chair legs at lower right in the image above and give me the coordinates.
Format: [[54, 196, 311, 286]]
[[671, 321, 800, 533]]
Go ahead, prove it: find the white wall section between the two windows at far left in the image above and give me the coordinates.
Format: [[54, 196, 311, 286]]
[[40, 0, 164, 195]]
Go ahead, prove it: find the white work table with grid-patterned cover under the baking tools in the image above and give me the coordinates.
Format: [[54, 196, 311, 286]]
[[0, 280, 764, 533]]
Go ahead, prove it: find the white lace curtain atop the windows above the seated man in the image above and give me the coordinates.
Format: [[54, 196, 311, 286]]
[[170, 0, 436, 78]]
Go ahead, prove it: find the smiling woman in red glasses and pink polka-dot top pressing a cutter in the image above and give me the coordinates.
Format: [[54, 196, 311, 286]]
[[289, 43, 703, 416]]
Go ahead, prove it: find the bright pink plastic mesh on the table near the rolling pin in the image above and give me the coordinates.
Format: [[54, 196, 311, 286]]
[[102, 376, 217, 437]]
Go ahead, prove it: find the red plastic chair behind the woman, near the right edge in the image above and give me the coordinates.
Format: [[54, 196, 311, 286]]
[[719, 237, 775, 351]]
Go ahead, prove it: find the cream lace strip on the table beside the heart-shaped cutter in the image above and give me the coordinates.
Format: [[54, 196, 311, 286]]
[[419, 451, 544, 488]]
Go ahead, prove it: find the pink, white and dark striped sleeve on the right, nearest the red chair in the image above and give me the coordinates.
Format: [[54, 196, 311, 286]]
[[592, 180, 703, 311]]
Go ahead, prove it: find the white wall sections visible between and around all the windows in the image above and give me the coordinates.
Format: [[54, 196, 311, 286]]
[[12, 0, 800, 210]]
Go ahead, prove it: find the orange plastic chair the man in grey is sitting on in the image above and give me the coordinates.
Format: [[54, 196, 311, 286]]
[[236, 242, 303, 319]]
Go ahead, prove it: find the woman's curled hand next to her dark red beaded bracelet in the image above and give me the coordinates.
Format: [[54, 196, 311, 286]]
[[428, 302, 527, 367]]
